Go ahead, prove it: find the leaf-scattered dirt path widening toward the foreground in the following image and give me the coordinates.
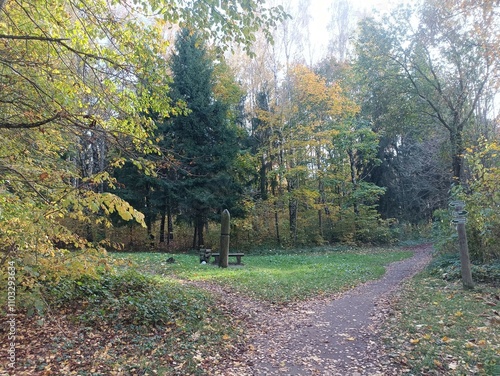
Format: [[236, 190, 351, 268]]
[[207, 245, 432, 376]]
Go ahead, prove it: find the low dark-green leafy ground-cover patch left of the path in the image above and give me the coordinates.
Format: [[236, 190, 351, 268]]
[[44, 271, 209, 326]]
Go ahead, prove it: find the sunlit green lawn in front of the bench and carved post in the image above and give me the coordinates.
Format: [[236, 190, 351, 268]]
[[114, 249, 411, 304]]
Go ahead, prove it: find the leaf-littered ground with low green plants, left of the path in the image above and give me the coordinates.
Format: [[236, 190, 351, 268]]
[[0, 270, 241, 376]]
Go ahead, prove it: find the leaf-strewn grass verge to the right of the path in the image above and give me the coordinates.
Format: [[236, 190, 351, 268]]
[[380, 272, 500, 375]]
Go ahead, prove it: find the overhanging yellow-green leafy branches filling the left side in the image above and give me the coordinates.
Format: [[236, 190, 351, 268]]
[[0, 0, 288, 302]]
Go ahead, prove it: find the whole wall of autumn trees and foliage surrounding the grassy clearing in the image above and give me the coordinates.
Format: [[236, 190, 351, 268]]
[[0, 0, 500, 288]]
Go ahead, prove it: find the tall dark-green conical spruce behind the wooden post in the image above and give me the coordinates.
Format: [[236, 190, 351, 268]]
[[162, 29, 239, 247]]
